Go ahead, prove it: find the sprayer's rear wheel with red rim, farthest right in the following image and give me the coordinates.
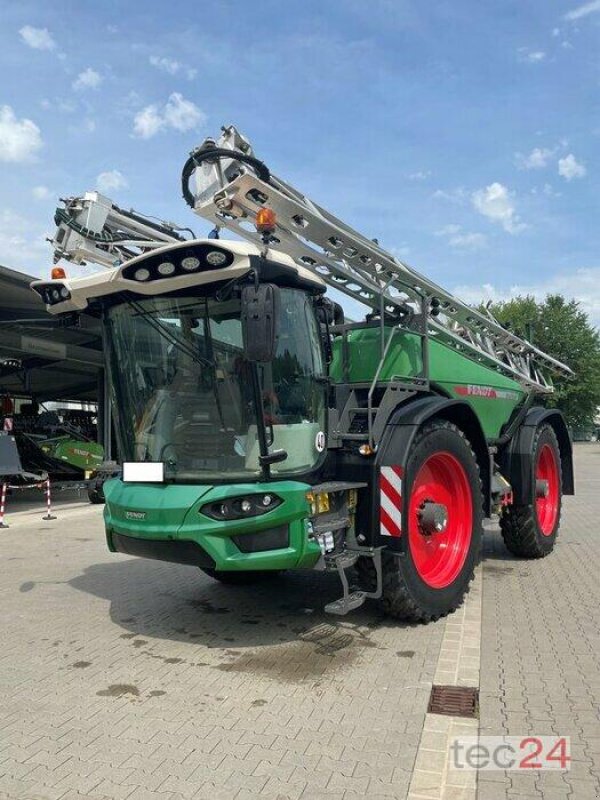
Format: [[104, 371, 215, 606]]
[[500, 425, 562, 558]]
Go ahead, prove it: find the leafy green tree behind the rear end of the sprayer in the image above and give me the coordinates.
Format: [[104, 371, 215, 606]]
[[490, 294, 600, 428]]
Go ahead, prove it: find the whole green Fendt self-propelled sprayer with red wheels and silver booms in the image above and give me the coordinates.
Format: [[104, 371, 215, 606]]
[[32, 127, 574, 622]]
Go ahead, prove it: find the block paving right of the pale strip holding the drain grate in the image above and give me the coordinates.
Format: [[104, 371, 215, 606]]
[[478, 444, 600, 800]]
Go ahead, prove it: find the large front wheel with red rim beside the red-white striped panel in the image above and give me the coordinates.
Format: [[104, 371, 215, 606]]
[[358, 420, 483, 622]]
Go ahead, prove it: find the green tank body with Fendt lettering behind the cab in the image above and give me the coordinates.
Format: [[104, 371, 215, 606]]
[[330, 327, 526, 439]]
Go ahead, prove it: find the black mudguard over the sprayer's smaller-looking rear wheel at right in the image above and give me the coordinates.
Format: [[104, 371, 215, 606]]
[[499, 406, 575, 506]]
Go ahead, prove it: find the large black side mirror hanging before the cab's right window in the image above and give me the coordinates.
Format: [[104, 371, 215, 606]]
[[241, 283, 279, 362]]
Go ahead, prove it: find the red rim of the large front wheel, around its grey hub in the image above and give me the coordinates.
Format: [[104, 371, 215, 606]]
[[408, 452, 473, 589]]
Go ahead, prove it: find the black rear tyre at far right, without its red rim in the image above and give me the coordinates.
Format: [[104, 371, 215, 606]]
[[500, 425, 562, 558]]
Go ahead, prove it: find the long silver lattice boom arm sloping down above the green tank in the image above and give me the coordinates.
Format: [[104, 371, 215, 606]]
[[182, 126, 572, 393]]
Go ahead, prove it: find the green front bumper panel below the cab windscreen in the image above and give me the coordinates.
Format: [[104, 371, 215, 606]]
[[104, 478, 321, 570]]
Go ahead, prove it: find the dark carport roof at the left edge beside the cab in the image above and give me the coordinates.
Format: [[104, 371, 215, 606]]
[[0, 266, 102, 401]]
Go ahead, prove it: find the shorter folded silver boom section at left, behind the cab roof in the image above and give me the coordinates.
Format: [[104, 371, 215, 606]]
[[52, 192, 191, 267]]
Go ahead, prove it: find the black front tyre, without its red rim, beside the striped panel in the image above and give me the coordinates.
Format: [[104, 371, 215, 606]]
[[357, 419, 483, 622]]
